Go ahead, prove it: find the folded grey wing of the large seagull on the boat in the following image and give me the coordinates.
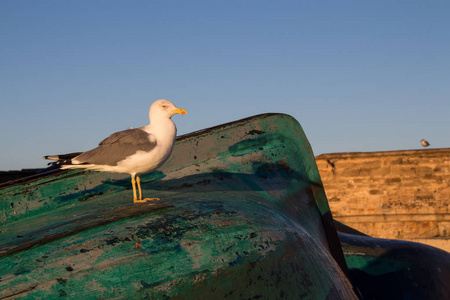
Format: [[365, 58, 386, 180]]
[[74, 129, 156, 166]]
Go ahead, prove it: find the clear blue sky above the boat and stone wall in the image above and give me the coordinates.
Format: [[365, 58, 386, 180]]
[[0, 0, 450, 170]]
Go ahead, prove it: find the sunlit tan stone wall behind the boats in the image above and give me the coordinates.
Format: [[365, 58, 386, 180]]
[[316, 148, 450, 251]]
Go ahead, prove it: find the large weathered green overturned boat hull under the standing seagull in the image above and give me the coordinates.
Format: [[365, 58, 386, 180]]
[[0, 114, 356, 299]]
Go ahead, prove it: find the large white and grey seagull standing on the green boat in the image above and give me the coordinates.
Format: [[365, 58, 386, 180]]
[[44, 99, 187, 203]]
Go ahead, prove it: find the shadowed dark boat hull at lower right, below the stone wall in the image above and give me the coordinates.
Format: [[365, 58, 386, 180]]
[[339, 233, 450, 300]]
